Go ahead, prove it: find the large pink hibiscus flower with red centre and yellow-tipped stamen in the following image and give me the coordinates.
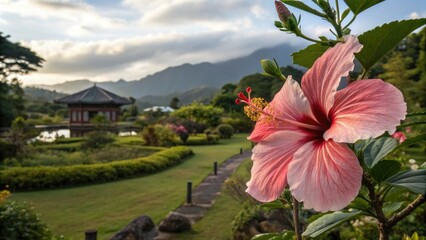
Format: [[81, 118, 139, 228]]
[[237, 36, 407, 212]]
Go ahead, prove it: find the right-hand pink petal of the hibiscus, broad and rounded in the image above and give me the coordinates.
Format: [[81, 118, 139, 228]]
[[324, 79, 407, 143]]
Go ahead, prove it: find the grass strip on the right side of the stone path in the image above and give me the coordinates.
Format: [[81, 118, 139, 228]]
[[171, 159, 251, 240]]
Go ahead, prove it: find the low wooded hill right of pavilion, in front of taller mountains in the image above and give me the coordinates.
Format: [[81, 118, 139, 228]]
[[136, 86, 219, 109]]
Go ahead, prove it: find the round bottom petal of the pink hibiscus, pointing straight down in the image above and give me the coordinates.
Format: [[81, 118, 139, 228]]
[[287, 140, 362, 212]]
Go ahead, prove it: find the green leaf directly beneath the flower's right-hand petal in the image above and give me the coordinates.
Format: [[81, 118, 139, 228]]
[[364, 137, 398, 168]]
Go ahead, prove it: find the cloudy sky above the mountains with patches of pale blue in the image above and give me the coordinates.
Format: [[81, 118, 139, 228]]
[[0, 0, 426, 85]]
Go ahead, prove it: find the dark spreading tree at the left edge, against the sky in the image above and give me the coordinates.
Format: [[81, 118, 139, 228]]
[[0, 32, 44, 127]]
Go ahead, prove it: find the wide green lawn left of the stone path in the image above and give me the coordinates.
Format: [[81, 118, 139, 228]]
[[12, 134, 250, 240]]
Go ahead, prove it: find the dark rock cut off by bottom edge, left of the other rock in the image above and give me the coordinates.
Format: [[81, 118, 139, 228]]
[[110, 215, 158, 240]]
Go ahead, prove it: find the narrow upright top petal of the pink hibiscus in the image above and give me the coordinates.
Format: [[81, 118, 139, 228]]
[[302, 35, 362, 125]]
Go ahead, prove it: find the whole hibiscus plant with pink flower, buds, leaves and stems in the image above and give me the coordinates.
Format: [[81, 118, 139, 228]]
[[236, 0, 426, 240]]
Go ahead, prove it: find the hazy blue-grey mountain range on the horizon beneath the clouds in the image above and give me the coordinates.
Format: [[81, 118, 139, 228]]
[[38, 44, 296, 98]]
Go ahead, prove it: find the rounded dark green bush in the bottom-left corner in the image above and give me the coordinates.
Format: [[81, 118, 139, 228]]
[[0, 201, 52, 240]]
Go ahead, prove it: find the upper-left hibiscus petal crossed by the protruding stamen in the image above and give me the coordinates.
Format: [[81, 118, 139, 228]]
[[248, 76, 313, 142]]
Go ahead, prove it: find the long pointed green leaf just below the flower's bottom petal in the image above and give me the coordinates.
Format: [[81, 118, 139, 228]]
[[302, 211, 361, 237]]
